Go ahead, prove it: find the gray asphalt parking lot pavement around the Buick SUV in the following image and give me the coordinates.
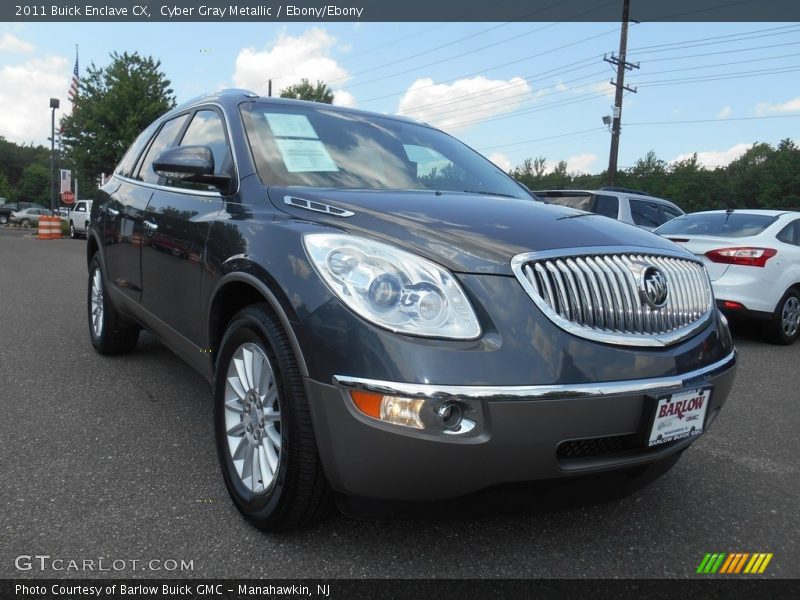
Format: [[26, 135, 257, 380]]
[[0, 231, 800, 578]]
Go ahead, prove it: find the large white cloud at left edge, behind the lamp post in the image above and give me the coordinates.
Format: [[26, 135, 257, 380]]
[[0, 56, 72, 144]]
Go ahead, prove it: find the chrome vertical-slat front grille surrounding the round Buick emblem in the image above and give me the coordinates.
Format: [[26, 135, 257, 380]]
[[512, 250, 714, 346]]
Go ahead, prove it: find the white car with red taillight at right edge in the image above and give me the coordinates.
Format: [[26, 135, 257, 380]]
[[655, 209, 800, 344]]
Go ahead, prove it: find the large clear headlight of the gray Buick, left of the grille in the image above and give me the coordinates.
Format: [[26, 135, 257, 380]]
[[303, 233, 481, 339]]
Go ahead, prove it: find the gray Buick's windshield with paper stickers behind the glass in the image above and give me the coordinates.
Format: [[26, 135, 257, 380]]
[[241, 104, 531, 200]]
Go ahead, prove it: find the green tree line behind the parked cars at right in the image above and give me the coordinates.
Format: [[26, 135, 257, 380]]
[[510, 139, 800, 212]]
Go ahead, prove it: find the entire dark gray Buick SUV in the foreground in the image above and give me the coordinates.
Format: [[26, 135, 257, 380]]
[[87, 90, 736, 530]]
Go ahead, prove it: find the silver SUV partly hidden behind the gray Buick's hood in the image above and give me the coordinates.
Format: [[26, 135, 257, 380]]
[[534, 187, 685, 231]]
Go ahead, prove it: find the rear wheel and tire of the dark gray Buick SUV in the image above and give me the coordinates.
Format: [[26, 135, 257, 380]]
[[86, 255, 139, 355]]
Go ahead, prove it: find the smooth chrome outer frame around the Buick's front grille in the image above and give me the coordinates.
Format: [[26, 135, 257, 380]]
[[511, 246, 716, 348]]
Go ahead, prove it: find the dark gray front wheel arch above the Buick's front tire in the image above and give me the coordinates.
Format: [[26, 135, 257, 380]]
[[206, 272, 308, 377]]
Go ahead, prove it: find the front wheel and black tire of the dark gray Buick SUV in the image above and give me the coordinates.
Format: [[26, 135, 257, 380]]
[[214, 304, 332, 531]]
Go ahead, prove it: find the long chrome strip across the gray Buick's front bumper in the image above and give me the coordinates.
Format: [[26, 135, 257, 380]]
[[333, 350, 736, 400]]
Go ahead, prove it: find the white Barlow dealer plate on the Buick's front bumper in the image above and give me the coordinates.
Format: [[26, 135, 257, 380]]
[[648, 388, 711, 447]]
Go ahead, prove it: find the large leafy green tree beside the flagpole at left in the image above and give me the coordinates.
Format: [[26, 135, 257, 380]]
[[61, 52, 175, 192]]
